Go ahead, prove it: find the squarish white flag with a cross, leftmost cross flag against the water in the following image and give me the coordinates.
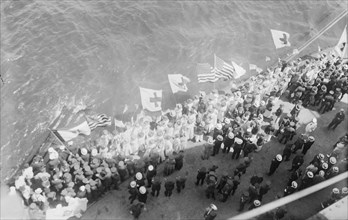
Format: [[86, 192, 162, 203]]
[[139, 87, 162, 112]]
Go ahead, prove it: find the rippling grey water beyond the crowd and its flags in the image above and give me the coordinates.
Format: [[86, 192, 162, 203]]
[[0, 0, 347, 180]]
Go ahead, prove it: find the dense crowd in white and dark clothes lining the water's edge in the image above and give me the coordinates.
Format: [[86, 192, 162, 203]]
[[8, 50, 348, 219]]
